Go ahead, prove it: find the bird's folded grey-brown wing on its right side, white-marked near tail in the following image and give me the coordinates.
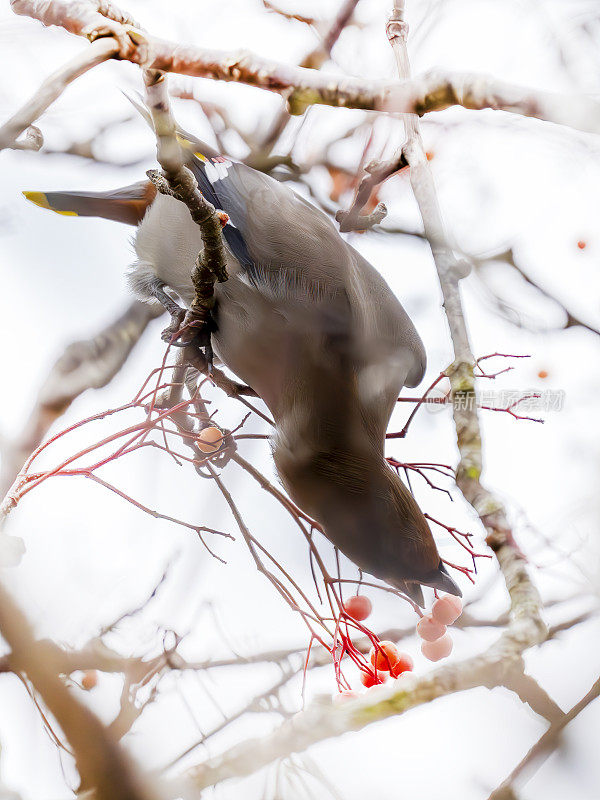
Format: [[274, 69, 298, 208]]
[[190, 151, 426, 396]]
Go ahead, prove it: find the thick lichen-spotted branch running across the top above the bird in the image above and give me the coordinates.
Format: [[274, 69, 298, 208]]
[[12, 0, 600, 133]]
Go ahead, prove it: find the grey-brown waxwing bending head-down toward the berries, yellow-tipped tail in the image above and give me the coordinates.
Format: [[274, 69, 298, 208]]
[[23, 123, 462, 607]]
